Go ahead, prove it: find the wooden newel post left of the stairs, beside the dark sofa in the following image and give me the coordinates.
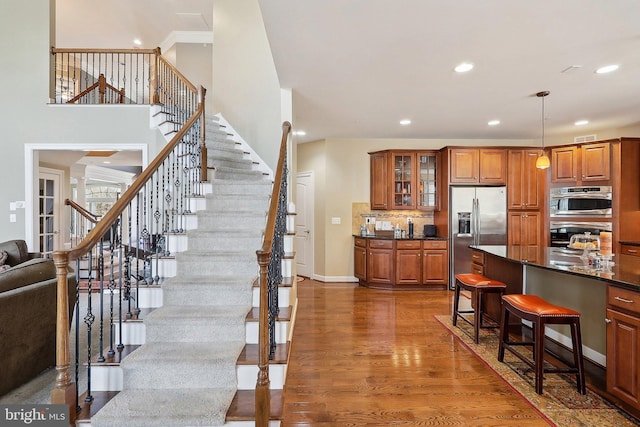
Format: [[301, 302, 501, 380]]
[[51, 251, 76, 419]]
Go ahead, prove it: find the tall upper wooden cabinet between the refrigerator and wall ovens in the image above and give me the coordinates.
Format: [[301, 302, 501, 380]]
[[507, 149, 546, 210]]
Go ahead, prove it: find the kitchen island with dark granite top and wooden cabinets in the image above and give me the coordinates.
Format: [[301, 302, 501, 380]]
[[471, 246, 640, 414]]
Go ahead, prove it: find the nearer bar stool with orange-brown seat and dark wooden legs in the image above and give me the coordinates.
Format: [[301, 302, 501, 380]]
[[498, 294, 587, 394]]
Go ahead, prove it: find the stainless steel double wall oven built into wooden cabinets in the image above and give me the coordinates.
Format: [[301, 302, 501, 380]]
[[549, 186, 612, 248]]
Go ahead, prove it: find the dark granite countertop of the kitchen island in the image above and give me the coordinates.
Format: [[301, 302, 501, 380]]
[[471, 245, 640, 291]]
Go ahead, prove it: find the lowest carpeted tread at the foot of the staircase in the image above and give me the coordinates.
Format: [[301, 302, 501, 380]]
[[91, 388, 236, 427]]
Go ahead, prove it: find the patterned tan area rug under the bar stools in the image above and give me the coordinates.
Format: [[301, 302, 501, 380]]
[[434, 315, 640, 427]]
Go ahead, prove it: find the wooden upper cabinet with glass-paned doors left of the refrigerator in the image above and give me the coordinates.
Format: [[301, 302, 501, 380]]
[[369, 150, 439, 210]]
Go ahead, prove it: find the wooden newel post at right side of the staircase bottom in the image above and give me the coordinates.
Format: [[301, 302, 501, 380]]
[[256, 250, 271, 427]]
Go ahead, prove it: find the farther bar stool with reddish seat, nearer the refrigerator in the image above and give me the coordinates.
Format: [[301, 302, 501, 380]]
[[452, 273, 507, 344]]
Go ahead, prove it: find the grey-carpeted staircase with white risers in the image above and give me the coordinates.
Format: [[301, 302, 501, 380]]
[[87, 117, 294, 427]]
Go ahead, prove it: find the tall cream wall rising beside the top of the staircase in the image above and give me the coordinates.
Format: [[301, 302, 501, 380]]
[[209, 0, 282, 169]]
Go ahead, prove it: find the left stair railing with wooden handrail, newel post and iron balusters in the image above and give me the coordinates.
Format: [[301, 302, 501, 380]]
[[51, 80, 207, 421]]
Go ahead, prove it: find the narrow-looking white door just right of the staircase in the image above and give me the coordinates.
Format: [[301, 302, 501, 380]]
[[295, 172, 313, 278]]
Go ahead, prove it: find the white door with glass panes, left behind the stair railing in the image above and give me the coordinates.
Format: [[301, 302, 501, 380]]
[[36, 168, 62, 258]]
